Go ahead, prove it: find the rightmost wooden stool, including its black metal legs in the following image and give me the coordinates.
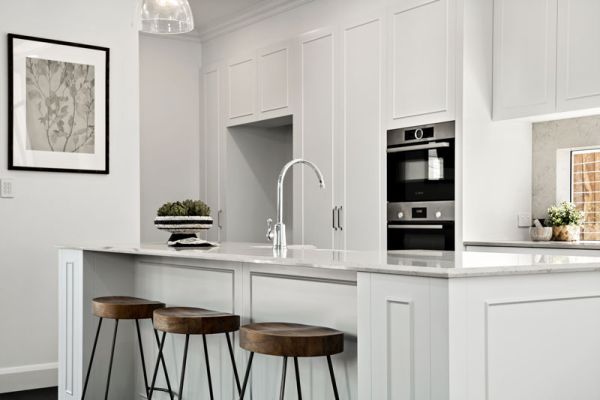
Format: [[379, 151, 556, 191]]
[[240, 322, 344, 400]]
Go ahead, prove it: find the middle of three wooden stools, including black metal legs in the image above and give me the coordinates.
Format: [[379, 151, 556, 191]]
[[148, 307, 241, 400]]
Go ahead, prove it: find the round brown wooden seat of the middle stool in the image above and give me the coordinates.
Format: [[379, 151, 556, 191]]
[[154, 307, 240, 335]]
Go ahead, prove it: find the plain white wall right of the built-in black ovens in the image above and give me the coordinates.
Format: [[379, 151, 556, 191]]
[[462, 0, 531, 241]]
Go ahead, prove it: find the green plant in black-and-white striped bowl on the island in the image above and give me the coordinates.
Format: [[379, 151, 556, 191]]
[[154, 200, 213, 245]]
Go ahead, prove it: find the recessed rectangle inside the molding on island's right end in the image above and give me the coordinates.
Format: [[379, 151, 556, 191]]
[[485, 294, 600, 399]]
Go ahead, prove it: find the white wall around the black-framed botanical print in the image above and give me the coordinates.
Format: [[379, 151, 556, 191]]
[[0, 0, 139, 393]]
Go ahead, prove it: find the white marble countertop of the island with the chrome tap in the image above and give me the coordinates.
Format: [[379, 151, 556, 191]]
[[61, 243, 600, 278]]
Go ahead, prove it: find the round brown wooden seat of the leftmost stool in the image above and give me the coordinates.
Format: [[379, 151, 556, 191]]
[[92, 296, 165, 319]]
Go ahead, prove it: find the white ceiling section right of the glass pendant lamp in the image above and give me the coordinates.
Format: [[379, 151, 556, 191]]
[[189, 0, 264, 31]]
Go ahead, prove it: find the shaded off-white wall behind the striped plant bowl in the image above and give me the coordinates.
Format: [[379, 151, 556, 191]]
[[140, 35, 204, 242]]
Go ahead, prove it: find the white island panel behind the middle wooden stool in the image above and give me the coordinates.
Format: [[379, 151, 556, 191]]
[[135, 257, 243, 400]]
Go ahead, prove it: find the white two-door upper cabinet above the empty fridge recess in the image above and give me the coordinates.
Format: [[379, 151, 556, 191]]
[[227, 41, 296, 126]]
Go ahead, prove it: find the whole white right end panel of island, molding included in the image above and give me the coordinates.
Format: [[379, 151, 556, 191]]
[[450, 272, 600, 400]]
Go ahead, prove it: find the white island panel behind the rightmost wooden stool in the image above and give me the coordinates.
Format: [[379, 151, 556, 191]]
[[244, 264, 360, 400]]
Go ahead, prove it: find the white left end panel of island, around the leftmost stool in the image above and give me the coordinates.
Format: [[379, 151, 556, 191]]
[[59, 249, 134, 400]]
